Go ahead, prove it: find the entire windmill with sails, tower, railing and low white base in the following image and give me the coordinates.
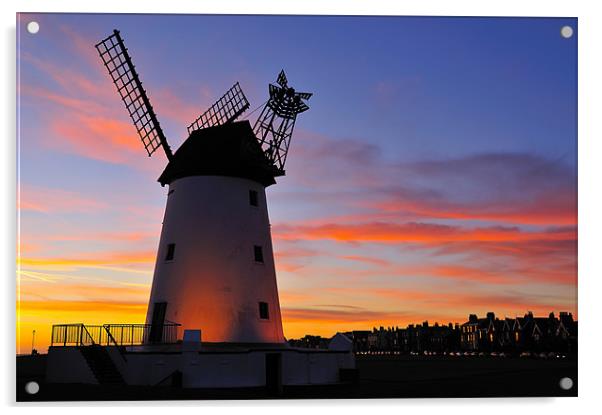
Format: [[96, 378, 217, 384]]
[[46, 30, 355, 395]]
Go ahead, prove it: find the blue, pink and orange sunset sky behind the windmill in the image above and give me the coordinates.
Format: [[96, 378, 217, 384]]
[[17, 14, 577, 353]]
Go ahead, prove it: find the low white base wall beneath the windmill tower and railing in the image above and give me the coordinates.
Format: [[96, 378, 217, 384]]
[[46, 347, 355, 388]]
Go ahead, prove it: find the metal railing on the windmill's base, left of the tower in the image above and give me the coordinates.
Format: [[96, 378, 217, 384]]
[[50, 323, 181, 346]]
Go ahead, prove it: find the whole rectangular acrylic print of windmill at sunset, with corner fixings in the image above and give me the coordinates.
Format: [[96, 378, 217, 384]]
[[16, 13, 578, 401]]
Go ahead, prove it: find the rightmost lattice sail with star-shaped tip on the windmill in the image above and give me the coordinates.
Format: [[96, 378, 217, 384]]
[[253, 71, 312, 175]]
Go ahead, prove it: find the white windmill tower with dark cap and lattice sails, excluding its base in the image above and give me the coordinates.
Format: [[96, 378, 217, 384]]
[[96, 30, 311, 343]]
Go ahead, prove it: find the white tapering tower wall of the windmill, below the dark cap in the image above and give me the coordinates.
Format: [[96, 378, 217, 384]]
[[147, 176, 284, 342]]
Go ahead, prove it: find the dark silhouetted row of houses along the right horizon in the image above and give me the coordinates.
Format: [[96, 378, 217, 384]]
[[289, 311, 577, 354]]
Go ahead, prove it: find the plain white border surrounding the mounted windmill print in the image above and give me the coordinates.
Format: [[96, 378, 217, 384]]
[[0, 0, 602, 415]]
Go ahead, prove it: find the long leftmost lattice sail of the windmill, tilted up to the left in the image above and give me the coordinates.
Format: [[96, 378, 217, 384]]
[[96, 30, 173, 160]]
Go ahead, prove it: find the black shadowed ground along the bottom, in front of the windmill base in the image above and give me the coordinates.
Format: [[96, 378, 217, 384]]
[[17, 355, 578, 401]]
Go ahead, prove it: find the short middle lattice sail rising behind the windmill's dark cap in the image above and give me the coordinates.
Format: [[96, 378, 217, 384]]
[[188, 82, 250, 134]]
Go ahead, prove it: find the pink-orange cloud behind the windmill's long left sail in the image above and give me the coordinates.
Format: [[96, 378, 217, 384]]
[[20, 43, 200, 169]]
